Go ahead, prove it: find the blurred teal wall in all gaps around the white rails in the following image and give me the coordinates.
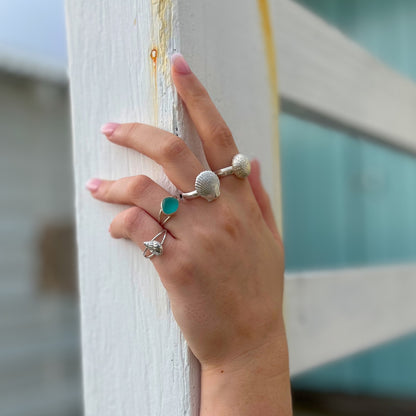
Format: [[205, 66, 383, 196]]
[[280, 0, 416, 398]]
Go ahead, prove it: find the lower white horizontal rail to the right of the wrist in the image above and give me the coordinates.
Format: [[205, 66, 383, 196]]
[[285, 264, 416, 374]]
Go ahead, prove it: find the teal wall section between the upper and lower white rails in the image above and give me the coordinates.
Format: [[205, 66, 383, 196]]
[[280, 114, 416, 270]]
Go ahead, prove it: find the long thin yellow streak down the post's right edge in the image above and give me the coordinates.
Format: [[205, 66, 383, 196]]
[[257, 0, 283, 234]]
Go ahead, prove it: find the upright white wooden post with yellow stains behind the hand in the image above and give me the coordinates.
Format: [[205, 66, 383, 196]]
[[67, 0, 280, 416]]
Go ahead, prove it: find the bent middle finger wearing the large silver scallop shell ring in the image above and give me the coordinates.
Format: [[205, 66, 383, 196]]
[[101, 123, 204, 192]]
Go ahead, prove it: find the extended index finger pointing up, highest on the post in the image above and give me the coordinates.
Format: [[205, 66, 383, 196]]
[[172, 54, 238, 170]]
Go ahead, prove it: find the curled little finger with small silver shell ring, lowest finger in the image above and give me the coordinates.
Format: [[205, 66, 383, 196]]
[[109, 207, 175, 260]]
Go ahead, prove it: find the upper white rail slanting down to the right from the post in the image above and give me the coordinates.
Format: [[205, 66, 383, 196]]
[[271, 0, 416, 153]]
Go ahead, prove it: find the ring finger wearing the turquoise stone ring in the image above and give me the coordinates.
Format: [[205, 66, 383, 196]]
[[87, 175, 183, 235]]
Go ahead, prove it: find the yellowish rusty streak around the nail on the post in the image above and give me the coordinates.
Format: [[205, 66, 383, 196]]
[[149, 0, 173, 126]]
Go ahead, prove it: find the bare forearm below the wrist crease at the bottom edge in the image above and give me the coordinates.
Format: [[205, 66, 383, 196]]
[[200, 336, 292, 416]]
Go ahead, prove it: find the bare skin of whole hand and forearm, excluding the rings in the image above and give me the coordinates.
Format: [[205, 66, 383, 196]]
[[88, 55, 292, 416]]
